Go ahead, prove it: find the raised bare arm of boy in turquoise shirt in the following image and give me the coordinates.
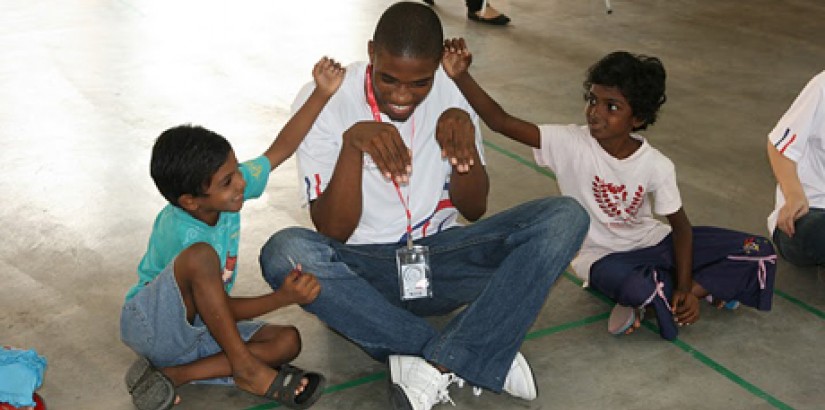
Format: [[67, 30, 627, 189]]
[[264, 57, 345, 171]]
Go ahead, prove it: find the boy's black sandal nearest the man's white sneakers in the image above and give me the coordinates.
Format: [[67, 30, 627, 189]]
[[264, 364, 326, 409]]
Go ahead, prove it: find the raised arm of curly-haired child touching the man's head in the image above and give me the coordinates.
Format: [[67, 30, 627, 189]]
[[441, 38, 541, 148]]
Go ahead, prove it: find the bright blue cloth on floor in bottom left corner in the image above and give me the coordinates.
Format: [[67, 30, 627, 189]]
[[0, 348, 46, 407]]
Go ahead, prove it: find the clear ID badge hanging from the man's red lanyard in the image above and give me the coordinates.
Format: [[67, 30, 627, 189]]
[[395, 245, 433, 300]]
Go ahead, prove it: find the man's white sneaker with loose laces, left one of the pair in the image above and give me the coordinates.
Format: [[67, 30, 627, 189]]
[[389, 355, 456, 410]]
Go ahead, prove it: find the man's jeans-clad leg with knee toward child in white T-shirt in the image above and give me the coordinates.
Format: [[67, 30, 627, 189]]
[[410, 197, 589, 392]]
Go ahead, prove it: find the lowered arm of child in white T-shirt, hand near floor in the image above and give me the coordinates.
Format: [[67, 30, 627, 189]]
[[667, 208, 699, 324]]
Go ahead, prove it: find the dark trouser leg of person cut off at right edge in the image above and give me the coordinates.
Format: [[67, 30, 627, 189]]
[[773, 208, 825, 266]]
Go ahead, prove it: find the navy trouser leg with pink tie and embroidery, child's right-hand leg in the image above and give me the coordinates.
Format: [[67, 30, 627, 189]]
[[693, 226, 776, 310]]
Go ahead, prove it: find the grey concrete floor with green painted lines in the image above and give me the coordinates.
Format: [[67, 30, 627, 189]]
[[0, 0, 825, 410]]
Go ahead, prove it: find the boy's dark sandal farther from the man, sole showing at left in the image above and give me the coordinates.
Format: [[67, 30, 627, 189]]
[[125, 357, 175, 410]]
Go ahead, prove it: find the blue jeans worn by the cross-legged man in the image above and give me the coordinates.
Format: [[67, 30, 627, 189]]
[[260, 197, 589, 392]]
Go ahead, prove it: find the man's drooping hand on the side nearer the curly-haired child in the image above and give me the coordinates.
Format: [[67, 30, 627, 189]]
[[435, 108, 477, 174]]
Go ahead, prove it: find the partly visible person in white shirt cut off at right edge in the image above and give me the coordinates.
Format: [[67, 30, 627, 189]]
[[768, 71, 825, 266]]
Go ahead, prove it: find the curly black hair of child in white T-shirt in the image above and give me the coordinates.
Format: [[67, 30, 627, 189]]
[[584, 51, 667, 131]]
